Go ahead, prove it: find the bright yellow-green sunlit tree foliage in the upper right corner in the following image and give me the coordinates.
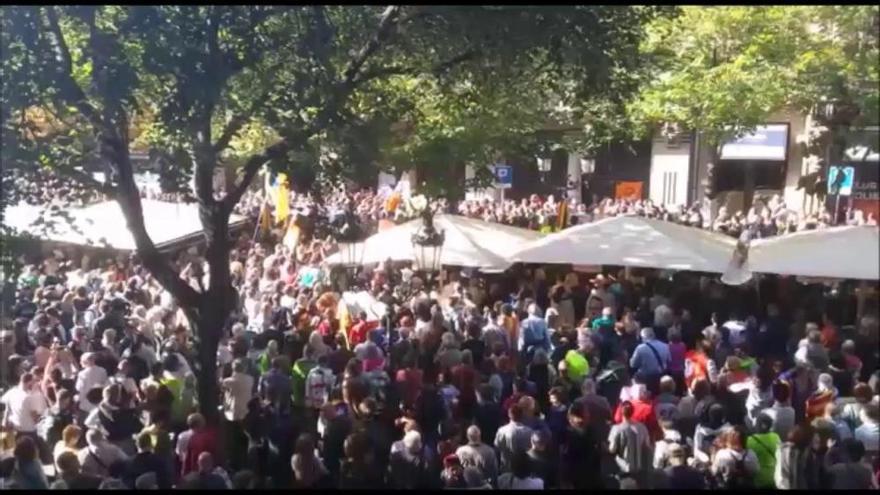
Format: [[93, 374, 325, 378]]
[[629, 6, 878, 210]]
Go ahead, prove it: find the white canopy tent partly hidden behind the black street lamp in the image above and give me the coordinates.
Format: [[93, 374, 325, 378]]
[[326, 214, 541, 272]]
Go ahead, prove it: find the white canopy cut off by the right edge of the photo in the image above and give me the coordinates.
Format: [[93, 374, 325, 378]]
[[748, 226, 880, 280]]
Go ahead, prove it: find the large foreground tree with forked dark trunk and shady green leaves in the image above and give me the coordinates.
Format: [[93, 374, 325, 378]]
[[0, 6, 667, 419]]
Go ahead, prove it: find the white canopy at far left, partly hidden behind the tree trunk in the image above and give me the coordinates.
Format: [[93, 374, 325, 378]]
[[4, 199, 245, 251]]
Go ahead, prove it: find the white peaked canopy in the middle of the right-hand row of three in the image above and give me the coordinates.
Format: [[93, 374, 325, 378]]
[[513, 216, 736, 273]]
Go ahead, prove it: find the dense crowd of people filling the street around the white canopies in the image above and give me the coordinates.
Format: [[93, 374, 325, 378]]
[[0, 172, 880, 490]]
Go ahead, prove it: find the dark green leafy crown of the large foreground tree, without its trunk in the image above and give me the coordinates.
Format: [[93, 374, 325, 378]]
[[2, 6, 669, 199]]
